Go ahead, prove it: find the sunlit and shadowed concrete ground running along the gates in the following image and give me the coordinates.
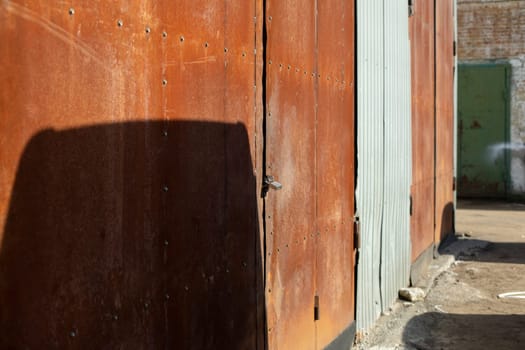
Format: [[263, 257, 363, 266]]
[[354, 201, 525, 350]]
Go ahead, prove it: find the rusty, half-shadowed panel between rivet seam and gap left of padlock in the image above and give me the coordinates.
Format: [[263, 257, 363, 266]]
[[163, 0, 265, 349]]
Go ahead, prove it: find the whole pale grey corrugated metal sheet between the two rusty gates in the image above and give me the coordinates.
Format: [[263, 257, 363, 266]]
[[356, 0, 412, 329]]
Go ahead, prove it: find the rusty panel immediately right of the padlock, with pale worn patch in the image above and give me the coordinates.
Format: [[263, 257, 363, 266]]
[[266, 0, 317, 349]]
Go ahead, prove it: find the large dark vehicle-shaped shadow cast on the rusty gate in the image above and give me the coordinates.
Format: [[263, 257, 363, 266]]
[[0, 122, 266, 349]]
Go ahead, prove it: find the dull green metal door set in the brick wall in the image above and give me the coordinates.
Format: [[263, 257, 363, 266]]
[[458, 64, 510, 198]]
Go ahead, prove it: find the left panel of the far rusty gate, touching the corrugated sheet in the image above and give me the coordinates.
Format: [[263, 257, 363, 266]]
[[410, 0, 435, 261]]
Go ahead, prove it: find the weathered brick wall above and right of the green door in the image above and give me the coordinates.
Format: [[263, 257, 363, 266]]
[[457, 0, 525, 195]]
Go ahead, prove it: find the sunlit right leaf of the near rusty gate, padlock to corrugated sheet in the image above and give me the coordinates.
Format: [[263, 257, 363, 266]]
[[266, 0, 354, 349]]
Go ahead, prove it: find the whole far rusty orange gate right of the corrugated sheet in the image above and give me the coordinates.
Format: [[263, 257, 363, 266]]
[[410, 0, 454, 261]]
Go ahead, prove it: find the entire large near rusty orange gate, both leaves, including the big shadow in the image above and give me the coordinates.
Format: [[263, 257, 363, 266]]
[[0, 0, 354, 349]]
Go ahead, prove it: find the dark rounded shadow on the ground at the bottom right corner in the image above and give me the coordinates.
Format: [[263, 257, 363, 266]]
[[403, 312, 525, 350]]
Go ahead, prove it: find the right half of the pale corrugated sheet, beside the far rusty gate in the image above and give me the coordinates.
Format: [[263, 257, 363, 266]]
[[381, 0, 412, 316]]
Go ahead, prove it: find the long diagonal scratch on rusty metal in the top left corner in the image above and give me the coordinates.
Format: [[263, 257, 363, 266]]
[[2, 0, 111, 71]]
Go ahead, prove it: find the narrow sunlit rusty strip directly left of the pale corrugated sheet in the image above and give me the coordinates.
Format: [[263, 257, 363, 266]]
[[316, 0, 355, 349]]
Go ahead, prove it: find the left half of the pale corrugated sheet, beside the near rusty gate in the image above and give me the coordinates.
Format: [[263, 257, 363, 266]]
[[356, 0, 384, 329]]
